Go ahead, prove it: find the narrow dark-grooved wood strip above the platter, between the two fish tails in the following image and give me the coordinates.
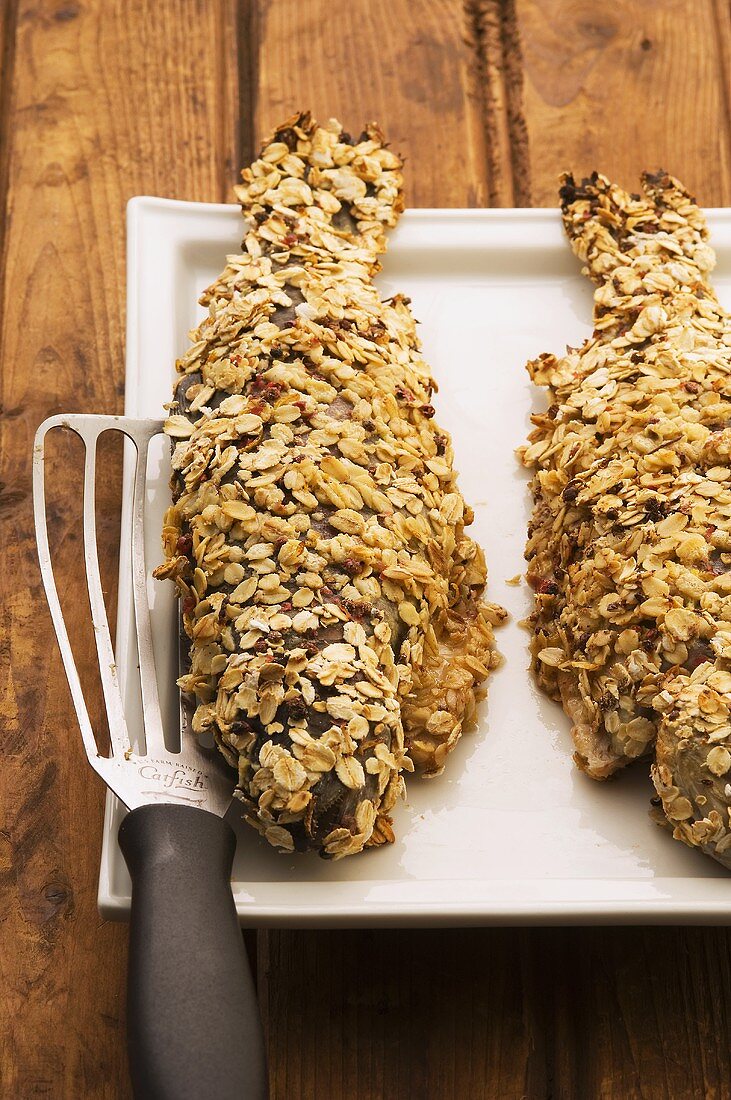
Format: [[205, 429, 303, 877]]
[[464, 0, 531, 207]]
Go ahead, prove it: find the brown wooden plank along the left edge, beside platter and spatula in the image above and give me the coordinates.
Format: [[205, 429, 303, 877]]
[[0, 0, 237, 1100]]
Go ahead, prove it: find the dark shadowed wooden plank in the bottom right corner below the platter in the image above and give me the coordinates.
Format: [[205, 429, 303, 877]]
[[535, 928, 731, 1100]]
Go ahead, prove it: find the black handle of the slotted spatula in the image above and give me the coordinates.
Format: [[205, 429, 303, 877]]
[[119, 804, 268, 1100]]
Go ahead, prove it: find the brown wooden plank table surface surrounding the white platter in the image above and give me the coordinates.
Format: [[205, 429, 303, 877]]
[[0, 0, 731, 1100]]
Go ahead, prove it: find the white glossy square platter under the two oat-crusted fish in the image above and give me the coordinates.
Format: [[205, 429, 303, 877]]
[[99, 198, 731, 926]]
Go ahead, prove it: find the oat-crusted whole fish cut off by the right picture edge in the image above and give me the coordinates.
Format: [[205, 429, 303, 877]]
[[523, 172, 731, 867]]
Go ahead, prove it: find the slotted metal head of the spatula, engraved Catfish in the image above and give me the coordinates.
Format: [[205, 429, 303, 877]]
[[33, 414, 235, 816]]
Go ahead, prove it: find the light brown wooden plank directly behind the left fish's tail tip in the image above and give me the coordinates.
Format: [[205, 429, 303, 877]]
[[251, 0, 489, 207]]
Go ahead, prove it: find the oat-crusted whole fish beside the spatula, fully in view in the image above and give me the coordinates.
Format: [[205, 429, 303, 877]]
[[157, 114, 503, 858]]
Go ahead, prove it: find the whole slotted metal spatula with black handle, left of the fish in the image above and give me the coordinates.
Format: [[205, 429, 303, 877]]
[[33, 415, 267, 1100]]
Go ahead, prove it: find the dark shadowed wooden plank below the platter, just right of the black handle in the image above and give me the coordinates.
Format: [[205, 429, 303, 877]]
[[259, 930, 547, 1100]]
